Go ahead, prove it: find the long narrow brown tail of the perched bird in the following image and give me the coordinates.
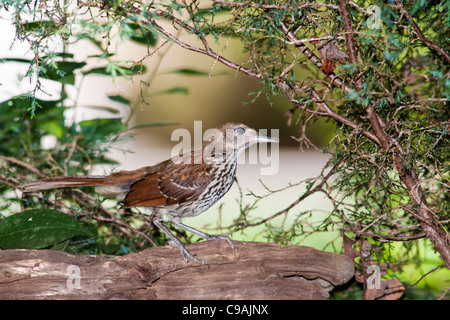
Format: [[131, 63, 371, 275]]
[[19, 176, 110, 192]]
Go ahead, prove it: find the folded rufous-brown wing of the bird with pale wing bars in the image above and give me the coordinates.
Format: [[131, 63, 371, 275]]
[[123, 160, 211, 208]]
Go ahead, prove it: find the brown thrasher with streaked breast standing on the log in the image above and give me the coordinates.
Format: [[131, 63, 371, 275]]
[[19, 122, 279, 264]]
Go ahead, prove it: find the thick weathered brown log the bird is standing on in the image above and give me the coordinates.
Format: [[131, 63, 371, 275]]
[[0, 241, 354, 299]]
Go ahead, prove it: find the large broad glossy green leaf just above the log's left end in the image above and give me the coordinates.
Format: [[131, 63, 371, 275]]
[[0, 209, 94, 249]]
